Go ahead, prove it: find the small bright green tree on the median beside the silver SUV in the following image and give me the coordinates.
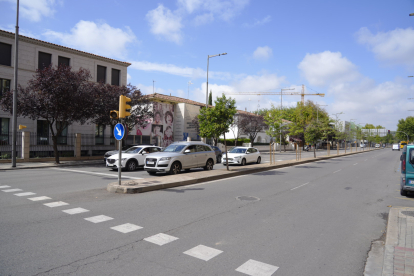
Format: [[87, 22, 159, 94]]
[[198, 94, 237, 170]]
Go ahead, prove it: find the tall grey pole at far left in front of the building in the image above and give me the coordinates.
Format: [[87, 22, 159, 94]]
[[12, 0, 19, 167]]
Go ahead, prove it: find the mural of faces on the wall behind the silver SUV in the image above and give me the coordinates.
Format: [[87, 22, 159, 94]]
[[151, 102, 174, 147]]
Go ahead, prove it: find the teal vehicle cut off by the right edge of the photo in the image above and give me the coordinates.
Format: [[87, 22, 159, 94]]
[[396, 144, 414, 196]]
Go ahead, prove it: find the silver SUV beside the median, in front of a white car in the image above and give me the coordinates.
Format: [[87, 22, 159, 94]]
[[144, 142, 216, 175]]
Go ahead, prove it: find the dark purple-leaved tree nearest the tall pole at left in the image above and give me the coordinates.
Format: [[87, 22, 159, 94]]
[[0, 65, 94, 164]]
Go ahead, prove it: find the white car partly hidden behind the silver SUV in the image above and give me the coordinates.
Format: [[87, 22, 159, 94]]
[[106, 146, 162, 171]]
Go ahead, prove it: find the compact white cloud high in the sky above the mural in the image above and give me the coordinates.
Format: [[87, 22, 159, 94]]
[[146, 4, 183, 44]]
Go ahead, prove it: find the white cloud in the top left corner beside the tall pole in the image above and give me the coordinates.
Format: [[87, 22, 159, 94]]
[[0, 0, 56, 22]]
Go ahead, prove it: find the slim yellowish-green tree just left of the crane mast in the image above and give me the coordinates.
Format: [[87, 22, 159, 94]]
[[264, 104, 289, 151]]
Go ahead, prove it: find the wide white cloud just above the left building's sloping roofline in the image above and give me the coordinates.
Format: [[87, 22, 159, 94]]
[[43, 20, 136, 58]]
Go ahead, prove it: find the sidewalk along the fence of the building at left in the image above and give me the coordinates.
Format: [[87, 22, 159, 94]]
[[0, 159, 104, 171]]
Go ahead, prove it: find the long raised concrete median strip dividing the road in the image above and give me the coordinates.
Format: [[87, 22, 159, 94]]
[[107, 149, 375, 194]]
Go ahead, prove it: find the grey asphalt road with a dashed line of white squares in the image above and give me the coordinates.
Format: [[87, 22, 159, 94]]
[[0, 150, 408, 276]]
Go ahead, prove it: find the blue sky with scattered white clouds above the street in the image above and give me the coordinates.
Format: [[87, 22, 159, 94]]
[[0, 0, 414, 130]]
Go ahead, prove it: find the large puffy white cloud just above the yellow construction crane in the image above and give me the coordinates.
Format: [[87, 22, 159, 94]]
[[298, 51, 360, 86]]
